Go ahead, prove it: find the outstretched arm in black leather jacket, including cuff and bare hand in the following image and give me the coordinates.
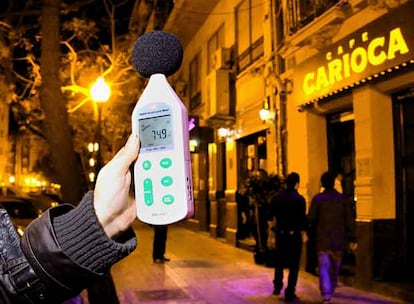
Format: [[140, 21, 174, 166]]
[[0, 136, 139, 304]]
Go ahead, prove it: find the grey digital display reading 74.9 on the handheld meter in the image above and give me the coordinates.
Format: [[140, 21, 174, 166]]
[[139, 115, 173, 148]]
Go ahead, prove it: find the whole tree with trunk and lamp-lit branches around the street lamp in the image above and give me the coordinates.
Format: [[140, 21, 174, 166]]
[[0, 0, 142, 202]]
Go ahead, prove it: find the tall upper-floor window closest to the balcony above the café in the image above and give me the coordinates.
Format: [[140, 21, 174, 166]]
[[236, 0, 266, 72]]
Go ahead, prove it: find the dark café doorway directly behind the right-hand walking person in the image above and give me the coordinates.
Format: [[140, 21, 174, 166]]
[[327, 112, 355, 199]]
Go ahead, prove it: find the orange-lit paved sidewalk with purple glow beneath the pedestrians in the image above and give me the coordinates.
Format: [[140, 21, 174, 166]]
[[81, 222, 405, 304]]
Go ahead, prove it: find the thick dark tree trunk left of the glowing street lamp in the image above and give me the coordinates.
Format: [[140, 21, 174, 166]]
[[40, 0, 82, 202]]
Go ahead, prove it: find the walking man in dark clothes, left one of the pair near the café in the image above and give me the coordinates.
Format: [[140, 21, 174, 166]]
[[269, 172, 307, 302]]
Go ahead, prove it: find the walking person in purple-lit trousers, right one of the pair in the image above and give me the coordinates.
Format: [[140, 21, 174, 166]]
[[308, 172, 357, 303]]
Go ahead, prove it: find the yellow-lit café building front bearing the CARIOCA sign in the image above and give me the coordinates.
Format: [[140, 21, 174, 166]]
[[280, 1, 414, 287]]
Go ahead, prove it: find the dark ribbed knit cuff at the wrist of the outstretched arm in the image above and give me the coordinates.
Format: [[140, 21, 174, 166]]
[[53, 191, 137, 273]]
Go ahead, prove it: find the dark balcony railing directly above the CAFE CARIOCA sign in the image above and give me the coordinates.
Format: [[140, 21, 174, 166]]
[[286, 0, 348, 35]]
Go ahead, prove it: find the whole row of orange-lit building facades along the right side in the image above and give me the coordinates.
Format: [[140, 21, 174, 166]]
[[154, 0, 414, 296]]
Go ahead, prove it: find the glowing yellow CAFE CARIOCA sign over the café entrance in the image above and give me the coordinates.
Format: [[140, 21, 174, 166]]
[[293, 1, 414, 105]]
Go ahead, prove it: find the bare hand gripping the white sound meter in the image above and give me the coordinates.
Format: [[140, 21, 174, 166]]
[[93, 135, 139, 238]]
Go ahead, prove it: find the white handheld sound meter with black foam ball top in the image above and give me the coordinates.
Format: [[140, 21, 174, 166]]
[[131, 31, 194, 225]]
